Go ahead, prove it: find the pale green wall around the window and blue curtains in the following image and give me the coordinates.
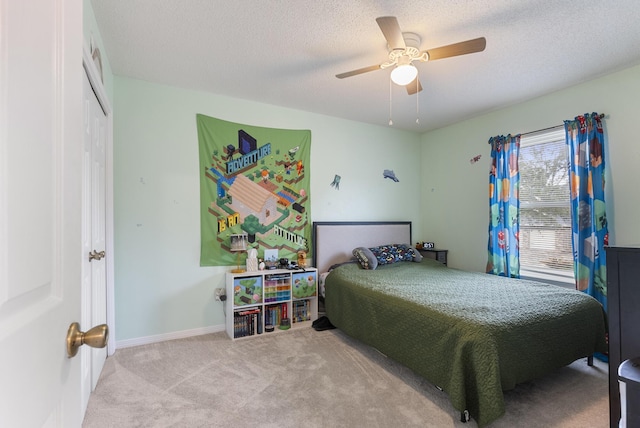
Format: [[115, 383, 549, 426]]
[[420, 66, 640, 271]]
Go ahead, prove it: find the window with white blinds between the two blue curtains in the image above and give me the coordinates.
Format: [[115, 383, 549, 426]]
[[519, 128, 574, 287]]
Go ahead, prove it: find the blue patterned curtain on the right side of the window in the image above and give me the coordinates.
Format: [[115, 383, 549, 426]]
[[564, 113, 609, 309]]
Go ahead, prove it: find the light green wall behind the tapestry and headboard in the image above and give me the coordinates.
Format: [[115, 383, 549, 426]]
[[113, 76, 421, 342]]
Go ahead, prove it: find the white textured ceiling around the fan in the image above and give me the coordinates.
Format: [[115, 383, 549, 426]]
[[91, 0, 640, 132]]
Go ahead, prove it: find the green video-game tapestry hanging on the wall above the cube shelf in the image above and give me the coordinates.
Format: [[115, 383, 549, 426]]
[[196, 114, 311, 266]]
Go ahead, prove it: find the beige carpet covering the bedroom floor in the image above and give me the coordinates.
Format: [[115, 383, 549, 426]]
[[83, 328, 609, 428]]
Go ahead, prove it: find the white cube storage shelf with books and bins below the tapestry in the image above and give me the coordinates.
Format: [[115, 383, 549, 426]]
[[225, 268, 318, 339]]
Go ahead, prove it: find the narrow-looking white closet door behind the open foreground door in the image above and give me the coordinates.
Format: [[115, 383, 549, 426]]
[[80, 67, 107, 410]]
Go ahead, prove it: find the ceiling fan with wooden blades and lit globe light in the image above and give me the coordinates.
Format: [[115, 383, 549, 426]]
[[336, 16, 487, 95]]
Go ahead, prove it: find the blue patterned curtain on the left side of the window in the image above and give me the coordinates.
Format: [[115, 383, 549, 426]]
[[487, 135, 520, 278]]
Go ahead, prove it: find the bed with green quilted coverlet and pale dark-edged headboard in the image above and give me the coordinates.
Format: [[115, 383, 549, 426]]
[[313, 222, 607, 427]]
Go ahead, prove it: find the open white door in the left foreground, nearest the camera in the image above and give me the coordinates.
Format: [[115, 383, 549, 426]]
[[0, 0, 86, 427]]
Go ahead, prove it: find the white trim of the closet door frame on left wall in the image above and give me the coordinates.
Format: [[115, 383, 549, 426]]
[[82, 47, 116, 355]]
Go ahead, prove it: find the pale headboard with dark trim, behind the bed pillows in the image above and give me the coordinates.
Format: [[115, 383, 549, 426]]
[[312, 221, 412, 273]]
